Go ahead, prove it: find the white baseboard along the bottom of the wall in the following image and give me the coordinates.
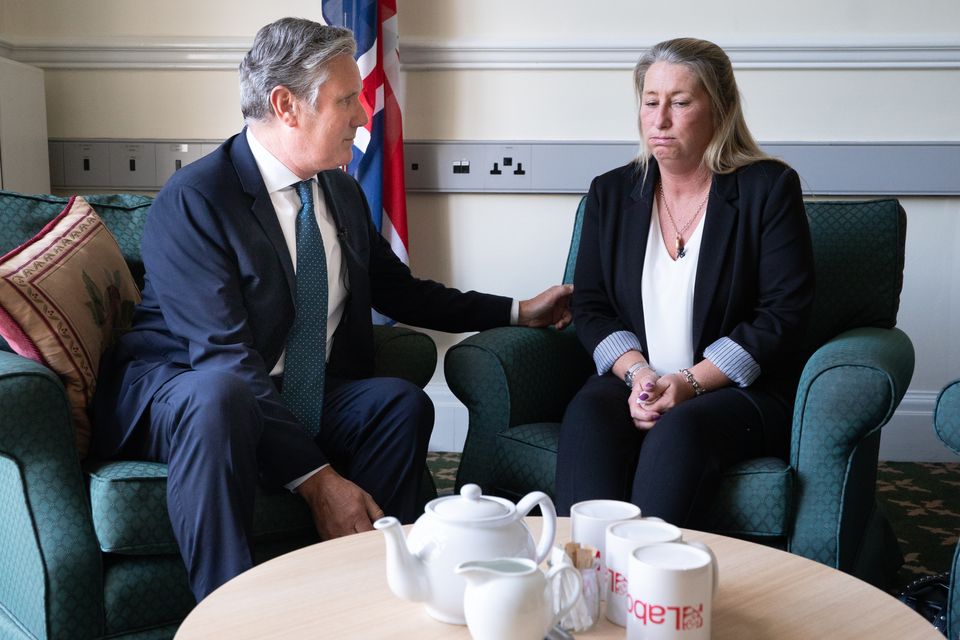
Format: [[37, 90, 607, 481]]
[[426, 382, 960, 462]]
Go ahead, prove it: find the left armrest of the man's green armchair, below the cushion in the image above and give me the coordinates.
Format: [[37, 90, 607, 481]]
[[0, 351, 103, 638]]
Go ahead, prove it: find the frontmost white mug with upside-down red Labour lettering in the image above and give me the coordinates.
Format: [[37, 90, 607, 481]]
[[627, 542, 719, 640]]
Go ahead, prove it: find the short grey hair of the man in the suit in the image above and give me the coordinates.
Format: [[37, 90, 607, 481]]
[[240, 18, 357, 121]]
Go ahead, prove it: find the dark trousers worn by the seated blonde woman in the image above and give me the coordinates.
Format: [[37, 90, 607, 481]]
[[556, 375, 790, 526]]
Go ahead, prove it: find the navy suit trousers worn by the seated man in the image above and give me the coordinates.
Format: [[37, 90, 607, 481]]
[[123, 371, 433, 602]]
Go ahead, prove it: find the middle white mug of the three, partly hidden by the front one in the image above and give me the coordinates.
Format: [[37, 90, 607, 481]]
[[604, 518, 683, 627]]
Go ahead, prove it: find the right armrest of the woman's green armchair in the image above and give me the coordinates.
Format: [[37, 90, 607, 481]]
[[790, 328, 914, 570]]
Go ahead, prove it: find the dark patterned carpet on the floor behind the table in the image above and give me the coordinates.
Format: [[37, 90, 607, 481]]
[[427, 453, 960, 590]]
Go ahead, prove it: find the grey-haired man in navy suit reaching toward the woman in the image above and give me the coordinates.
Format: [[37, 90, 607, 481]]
[[94, 18, 570, 600]]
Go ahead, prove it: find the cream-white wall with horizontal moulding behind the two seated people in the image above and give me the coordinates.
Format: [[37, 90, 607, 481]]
[[0, 0, 960, 460]]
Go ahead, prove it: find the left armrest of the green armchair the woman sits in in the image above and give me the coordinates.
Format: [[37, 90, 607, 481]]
[[444, 327, 594, 486]]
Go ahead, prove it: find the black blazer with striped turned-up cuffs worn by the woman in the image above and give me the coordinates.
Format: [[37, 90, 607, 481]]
[[573, 160, 814, 401]]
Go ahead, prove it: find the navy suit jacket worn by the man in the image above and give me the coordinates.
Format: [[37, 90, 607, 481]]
[[94, 132, 511, 468]]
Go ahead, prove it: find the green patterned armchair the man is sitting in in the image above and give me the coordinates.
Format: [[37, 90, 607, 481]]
[[0, 192, 437, 640]]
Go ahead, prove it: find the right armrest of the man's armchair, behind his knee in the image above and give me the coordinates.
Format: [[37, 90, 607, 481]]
[[373, 325, 437, 387]]
